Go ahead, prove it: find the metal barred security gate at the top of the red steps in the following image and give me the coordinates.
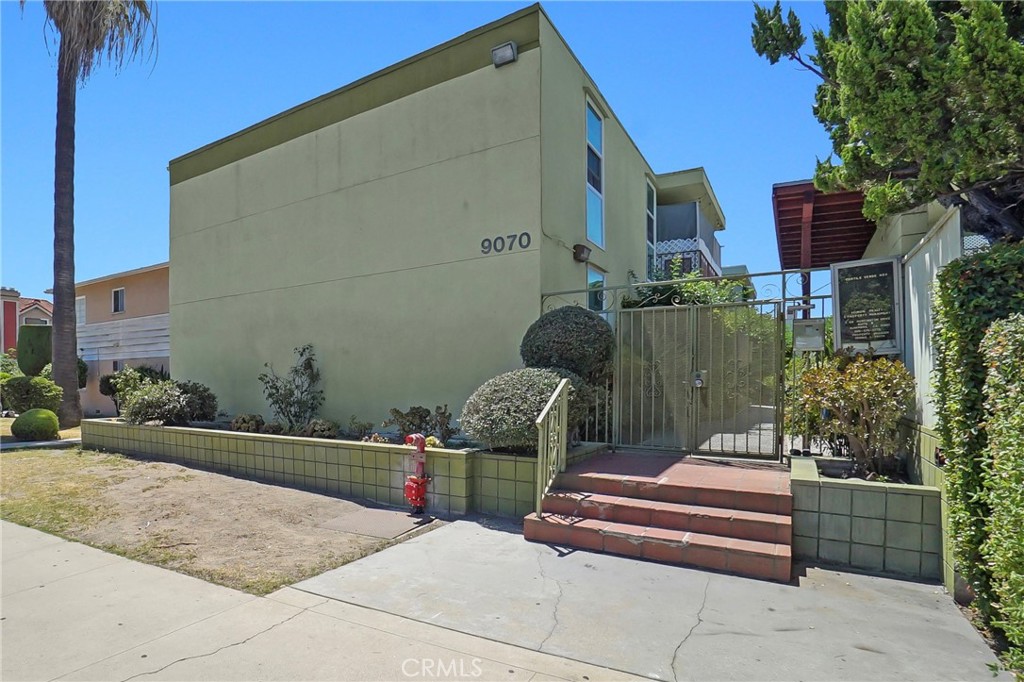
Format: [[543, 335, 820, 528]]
[[612, 301, 784, 459]]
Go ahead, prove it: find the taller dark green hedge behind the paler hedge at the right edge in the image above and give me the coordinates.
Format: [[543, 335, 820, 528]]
[[933, 244, 1024, 616]]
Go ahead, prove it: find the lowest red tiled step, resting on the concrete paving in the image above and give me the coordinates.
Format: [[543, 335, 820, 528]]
[[523, 514, 791, 582]]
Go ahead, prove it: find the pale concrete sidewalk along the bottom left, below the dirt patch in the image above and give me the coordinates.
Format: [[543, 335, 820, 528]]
[[0, 522, 629, 682]]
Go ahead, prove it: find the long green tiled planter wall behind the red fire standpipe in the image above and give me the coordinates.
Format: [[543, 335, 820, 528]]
[[82, 419, 605, 517]]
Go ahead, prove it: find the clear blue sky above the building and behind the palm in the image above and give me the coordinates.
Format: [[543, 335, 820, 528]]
[[0, 0, 829, 296]]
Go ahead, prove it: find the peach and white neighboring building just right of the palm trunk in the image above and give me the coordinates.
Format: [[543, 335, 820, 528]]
[[75, 263, 170, 417]]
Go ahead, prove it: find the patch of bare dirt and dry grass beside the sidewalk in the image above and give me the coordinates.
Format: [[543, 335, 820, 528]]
[[0, 450, 439, 594]]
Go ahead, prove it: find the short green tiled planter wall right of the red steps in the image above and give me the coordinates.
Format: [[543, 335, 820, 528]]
[[790, 459, 943, 580]]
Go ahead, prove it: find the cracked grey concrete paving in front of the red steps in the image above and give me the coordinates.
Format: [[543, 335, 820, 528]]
[[293, 521, 1012, 680]]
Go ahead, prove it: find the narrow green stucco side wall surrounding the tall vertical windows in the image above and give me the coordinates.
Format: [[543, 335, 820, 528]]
[[540, 14, 653, 301]]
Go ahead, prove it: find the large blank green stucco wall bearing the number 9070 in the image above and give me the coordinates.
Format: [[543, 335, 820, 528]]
[[170, 49, 541, 422]]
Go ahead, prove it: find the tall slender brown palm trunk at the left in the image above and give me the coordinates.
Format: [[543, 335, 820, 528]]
[[52, 39, 82, 428]]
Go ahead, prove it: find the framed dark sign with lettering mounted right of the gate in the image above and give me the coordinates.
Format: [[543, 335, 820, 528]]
[[831, 258, 903, 355]]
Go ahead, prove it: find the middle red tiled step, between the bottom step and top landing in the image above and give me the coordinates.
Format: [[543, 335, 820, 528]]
[[544, 491, 793, 545]]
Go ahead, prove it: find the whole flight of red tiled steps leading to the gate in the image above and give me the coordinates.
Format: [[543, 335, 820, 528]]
[[523, 458, 793, 582]]
